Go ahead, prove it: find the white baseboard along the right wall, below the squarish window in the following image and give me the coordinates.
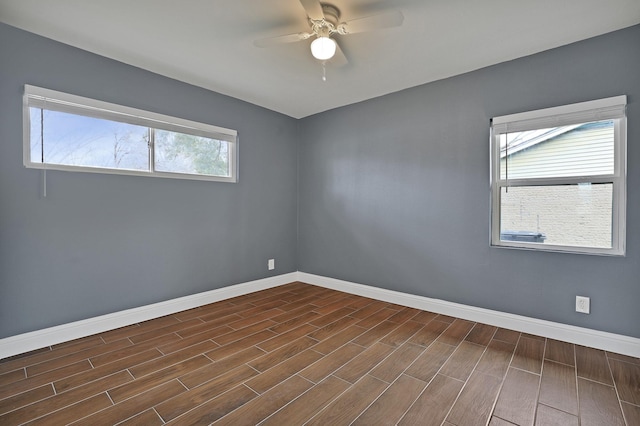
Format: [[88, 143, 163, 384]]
[[297, 272, 640, 358]]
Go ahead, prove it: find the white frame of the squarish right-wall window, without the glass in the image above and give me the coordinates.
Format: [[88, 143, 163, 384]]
[[490, 95, 627, 256]]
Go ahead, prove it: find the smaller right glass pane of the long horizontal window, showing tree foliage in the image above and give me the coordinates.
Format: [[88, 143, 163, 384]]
[[155, 130, 231, 177]]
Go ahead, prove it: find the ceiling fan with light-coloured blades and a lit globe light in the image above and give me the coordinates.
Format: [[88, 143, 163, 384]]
[[253, 0, 404, 66]]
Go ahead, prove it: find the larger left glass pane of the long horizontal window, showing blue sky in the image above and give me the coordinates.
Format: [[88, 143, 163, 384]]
[[29, 107, 149, 170]]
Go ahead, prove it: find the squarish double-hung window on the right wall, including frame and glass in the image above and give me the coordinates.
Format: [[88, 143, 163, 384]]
[[491, 96, 626, 255]]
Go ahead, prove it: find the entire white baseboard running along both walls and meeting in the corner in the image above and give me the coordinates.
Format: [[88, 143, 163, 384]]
[[0, 272, 640, 359]]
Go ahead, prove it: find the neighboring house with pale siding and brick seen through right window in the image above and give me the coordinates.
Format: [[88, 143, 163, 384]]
[[500, 121, 614, 247]]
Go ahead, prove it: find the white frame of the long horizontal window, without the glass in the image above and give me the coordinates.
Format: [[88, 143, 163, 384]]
[[23, 84, 238, 182]]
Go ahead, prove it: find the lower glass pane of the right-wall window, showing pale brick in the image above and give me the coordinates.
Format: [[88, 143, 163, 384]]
[[500, 183, 613, 248]]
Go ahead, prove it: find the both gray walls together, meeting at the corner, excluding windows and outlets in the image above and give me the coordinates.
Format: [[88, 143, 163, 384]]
[[0, 24, 640, 338]]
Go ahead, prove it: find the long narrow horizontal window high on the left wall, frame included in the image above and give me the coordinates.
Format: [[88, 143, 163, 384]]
[[24, 85, 237, 182]]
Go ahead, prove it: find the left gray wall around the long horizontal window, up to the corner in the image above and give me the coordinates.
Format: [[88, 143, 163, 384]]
[[0, 24, 298, 338]]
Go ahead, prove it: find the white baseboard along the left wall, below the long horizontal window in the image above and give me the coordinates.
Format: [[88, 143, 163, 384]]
[[0, 272, 298, 359]]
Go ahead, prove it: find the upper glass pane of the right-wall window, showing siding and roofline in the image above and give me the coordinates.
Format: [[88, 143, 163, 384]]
[[500, 120, 614, 179]]
